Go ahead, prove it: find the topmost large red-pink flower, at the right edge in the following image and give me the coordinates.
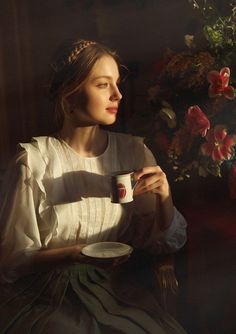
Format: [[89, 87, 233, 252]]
[[207, 67, 235, 99]]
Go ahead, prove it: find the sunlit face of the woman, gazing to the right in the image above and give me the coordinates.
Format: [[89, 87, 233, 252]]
[[68, 56, 122, 126]]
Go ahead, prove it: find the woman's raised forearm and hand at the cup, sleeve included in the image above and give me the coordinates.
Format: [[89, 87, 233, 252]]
[[132, 166, 187, 254]]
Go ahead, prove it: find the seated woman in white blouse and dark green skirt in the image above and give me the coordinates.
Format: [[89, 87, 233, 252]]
[[0, 40, 186, 334]]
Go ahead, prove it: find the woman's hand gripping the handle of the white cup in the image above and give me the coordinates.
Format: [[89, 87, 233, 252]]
[[134, 166, 170, 200]]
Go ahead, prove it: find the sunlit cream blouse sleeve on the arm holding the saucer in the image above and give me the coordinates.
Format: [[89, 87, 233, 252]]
[[0, 151, 42, 282]]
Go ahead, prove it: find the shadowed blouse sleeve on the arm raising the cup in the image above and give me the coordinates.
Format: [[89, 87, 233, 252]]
[[128, 140, 187, 253]]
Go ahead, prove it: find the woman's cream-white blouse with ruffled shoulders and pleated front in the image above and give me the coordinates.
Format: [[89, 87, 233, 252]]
[[0, 132, 186, 282]]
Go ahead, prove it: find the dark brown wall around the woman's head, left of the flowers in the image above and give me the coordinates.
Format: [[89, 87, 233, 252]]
[[0, 0, 199, 168]]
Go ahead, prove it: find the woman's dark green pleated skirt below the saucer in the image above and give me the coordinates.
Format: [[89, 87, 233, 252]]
[[0, 258, 186, 334]]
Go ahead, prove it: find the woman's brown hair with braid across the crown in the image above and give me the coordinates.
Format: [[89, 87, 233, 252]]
[[49, 40, 120, 129]]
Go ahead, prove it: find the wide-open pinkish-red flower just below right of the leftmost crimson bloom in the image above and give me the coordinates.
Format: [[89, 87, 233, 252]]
[[201, 124, 236, 162]]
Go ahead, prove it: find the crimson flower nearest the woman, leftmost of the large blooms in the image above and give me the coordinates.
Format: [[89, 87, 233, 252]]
[[186, 106, 210, 137]]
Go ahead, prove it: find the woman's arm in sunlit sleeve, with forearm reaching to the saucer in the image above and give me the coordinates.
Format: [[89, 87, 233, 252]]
[[0, 151, 83, 282]]
